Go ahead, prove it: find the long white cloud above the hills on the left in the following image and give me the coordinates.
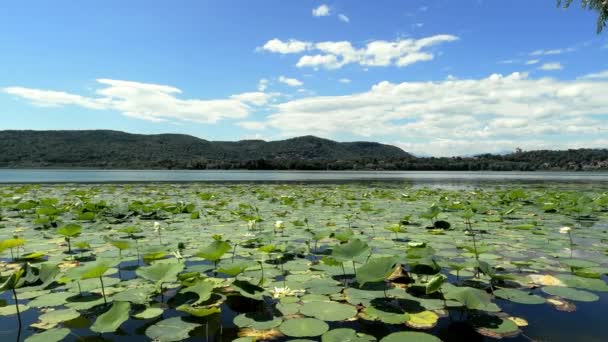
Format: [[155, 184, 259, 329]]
[[1, 79, 274, 123]]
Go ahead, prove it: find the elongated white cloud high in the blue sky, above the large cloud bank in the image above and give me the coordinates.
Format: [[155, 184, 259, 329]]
[[263, 34, 458, 69]]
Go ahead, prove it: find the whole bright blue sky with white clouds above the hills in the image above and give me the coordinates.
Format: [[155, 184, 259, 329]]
[[0, 0, 608, 156]]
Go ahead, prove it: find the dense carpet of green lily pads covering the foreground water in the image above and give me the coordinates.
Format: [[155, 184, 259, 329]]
[[0, 183, 608, 342]]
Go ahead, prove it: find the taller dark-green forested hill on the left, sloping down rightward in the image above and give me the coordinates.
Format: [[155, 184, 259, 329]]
[[0, 130, 411, 169]]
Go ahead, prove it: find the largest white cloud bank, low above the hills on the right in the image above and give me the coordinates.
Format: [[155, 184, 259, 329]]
[[266, 73, 608, 155]]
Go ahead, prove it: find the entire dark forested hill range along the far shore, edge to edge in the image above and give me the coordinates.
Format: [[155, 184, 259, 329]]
[[0, 130, 608, 171]]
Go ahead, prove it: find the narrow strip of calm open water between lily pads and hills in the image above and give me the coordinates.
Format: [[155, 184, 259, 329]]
[[0, 169, 608, 183]]
